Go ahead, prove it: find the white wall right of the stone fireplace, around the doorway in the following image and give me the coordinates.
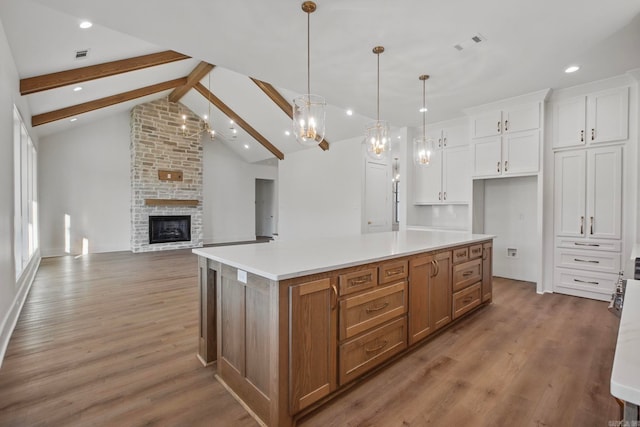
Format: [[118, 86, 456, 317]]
[[203, 137, 276, 244]]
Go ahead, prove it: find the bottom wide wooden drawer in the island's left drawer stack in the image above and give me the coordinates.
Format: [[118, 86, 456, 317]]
[[339, 316, 407, 385]]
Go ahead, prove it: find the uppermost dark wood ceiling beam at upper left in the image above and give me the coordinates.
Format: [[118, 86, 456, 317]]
[[20, 50, 190, 95]]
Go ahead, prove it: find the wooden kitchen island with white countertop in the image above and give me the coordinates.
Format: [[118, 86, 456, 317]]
[[193, 230, 493, 427]]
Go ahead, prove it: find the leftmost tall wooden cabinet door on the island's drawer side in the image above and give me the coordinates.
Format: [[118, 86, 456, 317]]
[[289, 278, 338, 414]]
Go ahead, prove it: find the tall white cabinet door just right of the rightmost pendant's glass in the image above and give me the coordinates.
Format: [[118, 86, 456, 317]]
[[442, 147, 471, 203]]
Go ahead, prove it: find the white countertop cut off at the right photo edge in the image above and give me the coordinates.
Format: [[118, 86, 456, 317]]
[[611, 279, 640, 405]]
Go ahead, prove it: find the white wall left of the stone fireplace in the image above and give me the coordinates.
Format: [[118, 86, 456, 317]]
[[39, 112, 131, 256]]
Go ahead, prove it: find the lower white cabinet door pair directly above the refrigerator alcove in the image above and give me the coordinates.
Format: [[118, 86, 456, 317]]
[[473, 129, 540, 178]]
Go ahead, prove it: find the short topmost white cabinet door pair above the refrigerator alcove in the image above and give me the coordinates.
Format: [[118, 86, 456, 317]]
[[471, 103, 540, 138]]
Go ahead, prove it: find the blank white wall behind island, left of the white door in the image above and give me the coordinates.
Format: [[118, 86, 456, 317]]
[[278, 137, 364, 240]]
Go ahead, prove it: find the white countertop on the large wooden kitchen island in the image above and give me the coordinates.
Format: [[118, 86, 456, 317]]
[[193, 230, 494, 280]]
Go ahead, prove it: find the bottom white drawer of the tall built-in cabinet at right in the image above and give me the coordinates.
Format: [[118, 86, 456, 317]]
[[553, 268, 618, 301]]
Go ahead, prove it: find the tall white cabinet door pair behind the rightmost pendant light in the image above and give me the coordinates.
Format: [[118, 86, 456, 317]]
[[414, 147, 471, 205]]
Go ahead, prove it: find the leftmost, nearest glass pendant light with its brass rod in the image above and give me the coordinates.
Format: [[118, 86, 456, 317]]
[[293, 1, 327, 146]]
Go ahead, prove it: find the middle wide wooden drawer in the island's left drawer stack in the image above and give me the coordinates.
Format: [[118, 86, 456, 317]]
[[340, 281, 407, 340]]
